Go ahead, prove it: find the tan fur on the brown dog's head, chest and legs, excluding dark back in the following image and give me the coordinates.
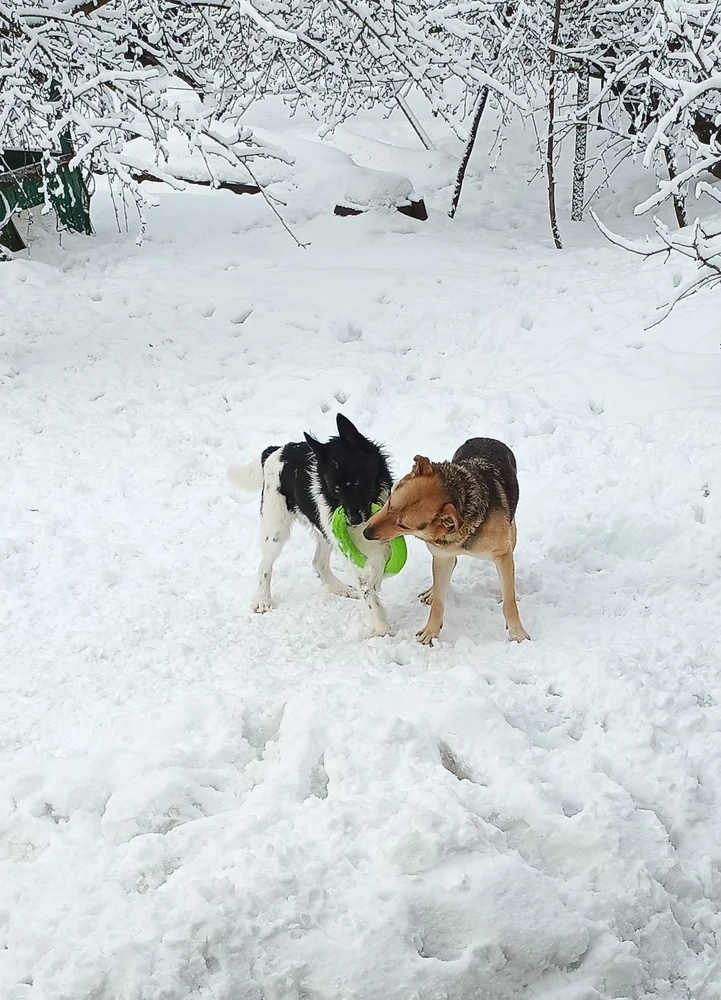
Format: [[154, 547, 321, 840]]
[[366, 455, 529, 646]]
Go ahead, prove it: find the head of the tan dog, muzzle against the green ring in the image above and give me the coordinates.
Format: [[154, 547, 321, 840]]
[[363, 455, 462, 544]]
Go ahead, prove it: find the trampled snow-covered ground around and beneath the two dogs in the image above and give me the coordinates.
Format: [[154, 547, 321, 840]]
[[0, 103, 721, 1000]]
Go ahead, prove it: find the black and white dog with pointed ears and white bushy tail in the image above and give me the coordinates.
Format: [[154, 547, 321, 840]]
[[228, 413, 393, 635]]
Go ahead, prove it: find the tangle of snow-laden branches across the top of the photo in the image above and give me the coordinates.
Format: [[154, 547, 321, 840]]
[[0, 0, 721, 242]]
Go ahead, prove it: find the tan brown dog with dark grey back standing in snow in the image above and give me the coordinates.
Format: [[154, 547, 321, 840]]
[[363, 438, 530, 646]]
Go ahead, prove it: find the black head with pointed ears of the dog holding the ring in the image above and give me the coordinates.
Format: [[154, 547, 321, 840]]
[[305, 413, 393, 524]]
